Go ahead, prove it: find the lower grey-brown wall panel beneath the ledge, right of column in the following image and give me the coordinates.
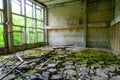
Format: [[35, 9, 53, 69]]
[[87, 27, 109, 48]]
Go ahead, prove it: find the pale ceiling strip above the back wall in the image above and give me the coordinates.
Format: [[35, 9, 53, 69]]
[[35, 0, 82, 8]]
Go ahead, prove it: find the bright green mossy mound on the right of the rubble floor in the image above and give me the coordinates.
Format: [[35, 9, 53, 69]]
[[67, 50, 118, 63]]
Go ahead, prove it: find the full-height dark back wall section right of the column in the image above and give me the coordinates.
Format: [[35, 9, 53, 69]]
[[87, 0, 113, 48]]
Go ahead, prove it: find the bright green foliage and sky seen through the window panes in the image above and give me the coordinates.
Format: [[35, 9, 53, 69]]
[[0, 0, 43, 47]]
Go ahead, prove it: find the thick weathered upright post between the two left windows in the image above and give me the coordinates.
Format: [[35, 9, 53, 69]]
[[4, 0, 14, 53]]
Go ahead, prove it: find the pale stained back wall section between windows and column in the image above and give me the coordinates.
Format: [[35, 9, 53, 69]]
[[48, 4, 84, 46]]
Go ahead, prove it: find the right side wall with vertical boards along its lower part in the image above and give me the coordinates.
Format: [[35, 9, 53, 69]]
[[111, 0, 120, 52]]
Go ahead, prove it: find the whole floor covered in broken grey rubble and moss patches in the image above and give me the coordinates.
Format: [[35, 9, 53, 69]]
[[0, 46, 120, 80]]
